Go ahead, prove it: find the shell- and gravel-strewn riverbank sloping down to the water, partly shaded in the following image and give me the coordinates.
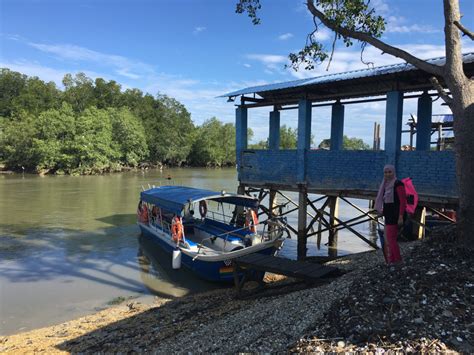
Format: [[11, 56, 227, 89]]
[[0, 229, 474, 353]]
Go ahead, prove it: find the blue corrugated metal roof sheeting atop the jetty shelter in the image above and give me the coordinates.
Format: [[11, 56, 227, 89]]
[[218, 52, 474, 97]]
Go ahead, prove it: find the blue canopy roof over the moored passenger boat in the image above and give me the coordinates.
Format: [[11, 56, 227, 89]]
[[140, 186, 258, 214]]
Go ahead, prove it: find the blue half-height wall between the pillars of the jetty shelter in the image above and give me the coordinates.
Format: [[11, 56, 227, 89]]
[[240, 150, 457, 198]]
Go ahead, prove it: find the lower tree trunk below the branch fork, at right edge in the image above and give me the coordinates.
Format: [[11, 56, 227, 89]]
[[451, 81, 474, 251]]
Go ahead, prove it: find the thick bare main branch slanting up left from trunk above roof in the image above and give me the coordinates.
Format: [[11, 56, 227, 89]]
[[306, 0, 444, 76]]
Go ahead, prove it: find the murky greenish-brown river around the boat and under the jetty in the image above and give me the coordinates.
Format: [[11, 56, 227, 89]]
[[0, 168, 375, 335]]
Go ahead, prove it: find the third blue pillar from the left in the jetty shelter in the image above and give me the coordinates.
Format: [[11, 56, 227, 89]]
[[296, 99, 311, 184]]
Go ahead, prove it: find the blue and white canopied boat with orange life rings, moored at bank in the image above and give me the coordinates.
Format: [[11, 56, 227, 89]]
[[137, 186, 287, 282]]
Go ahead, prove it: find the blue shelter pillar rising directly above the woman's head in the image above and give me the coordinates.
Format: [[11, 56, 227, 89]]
[[385, 91, 403, 164]]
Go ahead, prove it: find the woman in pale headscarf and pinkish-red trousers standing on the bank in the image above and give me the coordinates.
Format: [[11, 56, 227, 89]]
[[375, 165, 407, 264]]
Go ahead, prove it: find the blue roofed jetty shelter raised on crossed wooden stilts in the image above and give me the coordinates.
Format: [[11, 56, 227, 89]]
[[222, 53, 474, 260]]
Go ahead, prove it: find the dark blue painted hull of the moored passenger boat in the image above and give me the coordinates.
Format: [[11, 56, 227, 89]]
[[139, 225, 275, 283]]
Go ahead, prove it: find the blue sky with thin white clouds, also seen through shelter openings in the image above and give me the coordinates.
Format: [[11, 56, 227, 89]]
[[0, 0, 474, 145]]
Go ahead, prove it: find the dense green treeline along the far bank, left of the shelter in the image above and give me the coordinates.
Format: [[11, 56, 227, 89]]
[[0, 69, 235, 174]]
